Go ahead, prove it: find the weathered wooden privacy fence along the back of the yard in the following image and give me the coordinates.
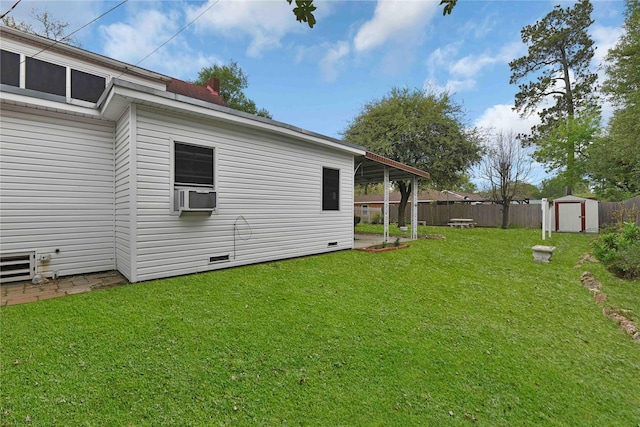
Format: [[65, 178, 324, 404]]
[[354, 196, 640, 228]]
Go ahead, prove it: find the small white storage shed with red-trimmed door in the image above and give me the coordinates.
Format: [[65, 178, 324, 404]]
[[551, 196, 599, 233]]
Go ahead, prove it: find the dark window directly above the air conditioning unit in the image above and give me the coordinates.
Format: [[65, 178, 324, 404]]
[[174, 143, 214, 188]]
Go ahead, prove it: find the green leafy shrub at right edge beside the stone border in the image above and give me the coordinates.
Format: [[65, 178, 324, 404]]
[[593, 222, 640, 279]]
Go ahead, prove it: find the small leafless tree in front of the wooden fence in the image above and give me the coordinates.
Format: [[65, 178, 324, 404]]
[[480, 131, 533, 229]]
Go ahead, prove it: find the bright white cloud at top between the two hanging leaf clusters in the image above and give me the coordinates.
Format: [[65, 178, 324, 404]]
[[353, 0, 438, 52]]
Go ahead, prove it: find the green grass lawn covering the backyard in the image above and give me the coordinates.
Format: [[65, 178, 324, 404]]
[[0, 226, 640, 426]]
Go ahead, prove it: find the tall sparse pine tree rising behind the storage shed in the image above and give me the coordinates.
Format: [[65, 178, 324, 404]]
[[509, 0, 598, 194]]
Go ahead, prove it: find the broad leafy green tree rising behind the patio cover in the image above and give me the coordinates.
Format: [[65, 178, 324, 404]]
[[342, 88, 481, 226]]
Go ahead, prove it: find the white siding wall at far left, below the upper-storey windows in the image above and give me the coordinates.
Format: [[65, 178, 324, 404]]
[[0, 106, 115, 276]]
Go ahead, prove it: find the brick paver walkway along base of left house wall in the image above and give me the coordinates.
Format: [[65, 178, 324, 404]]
[[0, 270, 127, 305]]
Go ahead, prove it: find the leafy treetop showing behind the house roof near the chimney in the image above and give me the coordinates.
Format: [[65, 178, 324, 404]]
[[194, 61, 272, 119]]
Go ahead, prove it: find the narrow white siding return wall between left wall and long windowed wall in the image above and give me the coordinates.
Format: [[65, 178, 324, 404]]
[[115, 110, 131, 280]]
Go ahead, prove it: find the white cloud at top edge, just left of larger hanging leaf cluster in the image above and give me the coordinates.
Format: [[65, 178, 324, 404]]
[[187, 0, 306, 57]]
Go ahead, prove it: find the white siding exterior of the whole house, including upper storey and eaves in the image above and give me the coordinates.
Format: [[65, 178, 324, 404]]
[[0, 27, 364, 282]]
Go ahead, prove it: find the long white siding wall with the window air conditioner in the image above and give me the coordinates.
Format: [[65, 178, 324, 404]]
[[134, 107, 353, 280]]
